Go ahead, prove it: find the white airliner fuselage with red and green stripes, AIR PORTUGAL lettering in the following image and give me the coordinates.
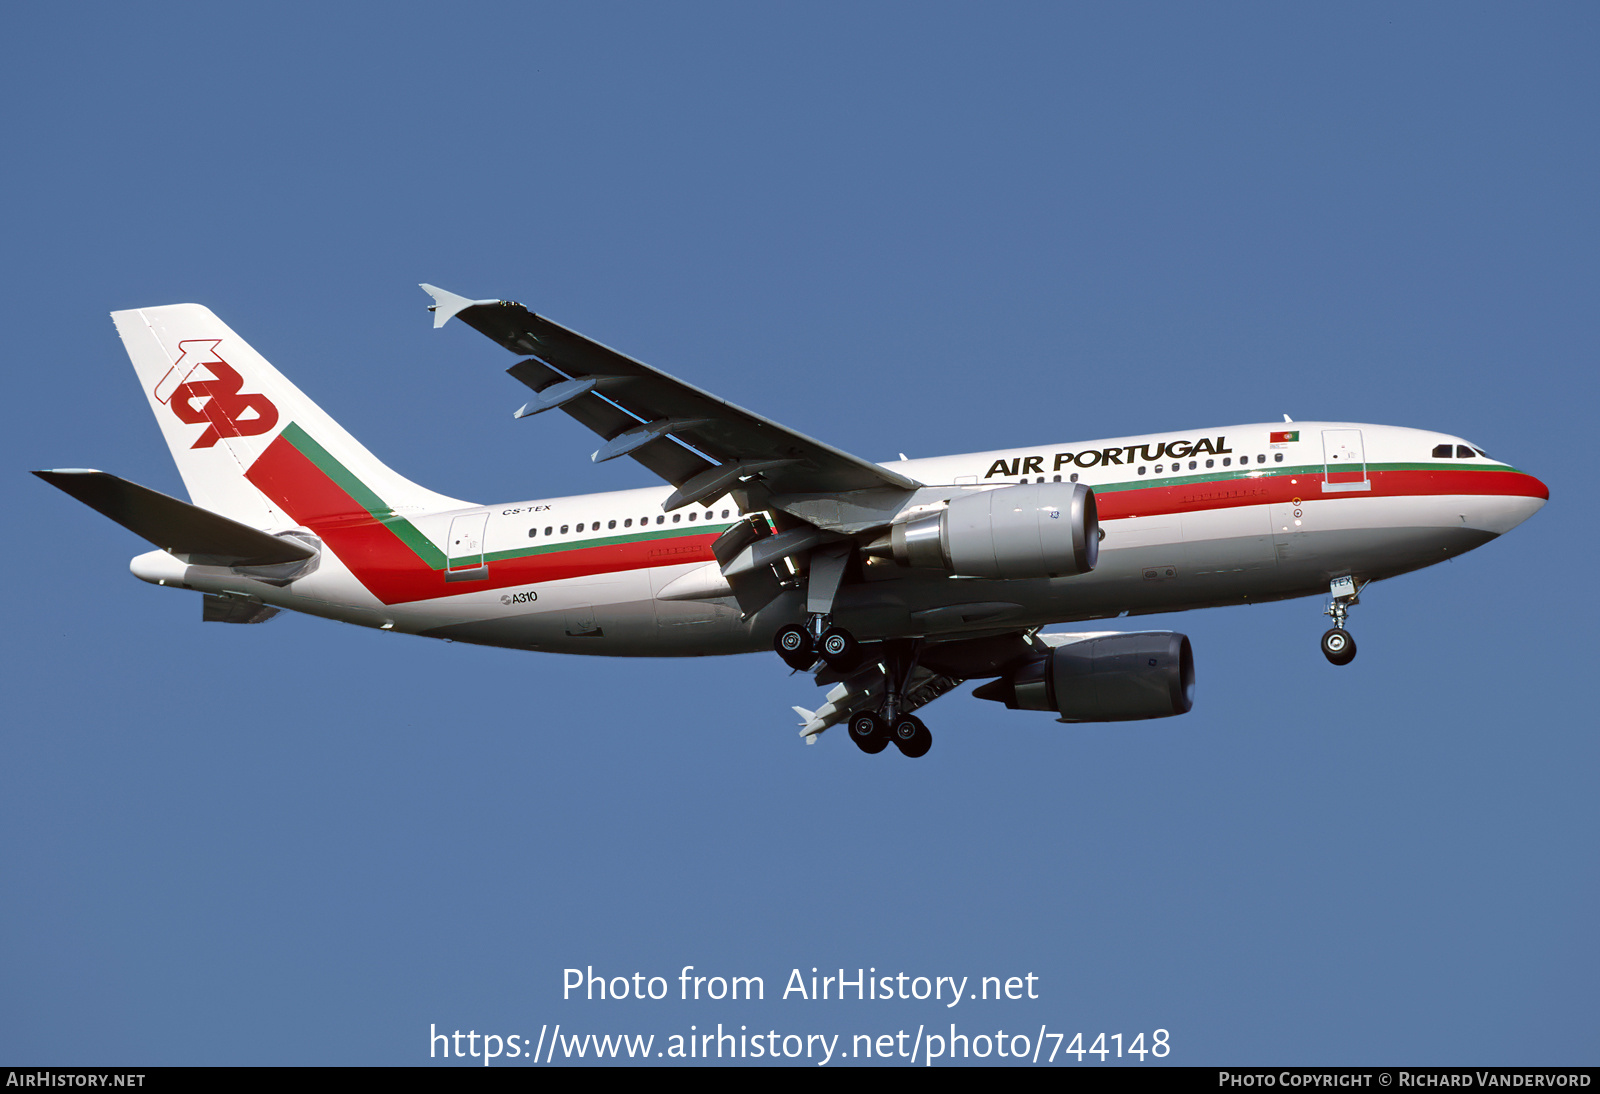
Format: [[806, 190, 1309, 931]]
[[133, 422, 1549, 656]]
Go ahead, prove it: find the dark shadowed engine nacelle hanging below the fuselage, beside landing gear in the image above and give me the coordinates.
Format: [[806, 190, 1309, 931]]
[[973, 630, 1195, 721]]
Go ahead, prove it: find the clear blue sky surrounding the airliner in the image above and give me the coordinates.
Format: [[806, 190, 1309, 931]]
[[0, 3, 1600, 1064]]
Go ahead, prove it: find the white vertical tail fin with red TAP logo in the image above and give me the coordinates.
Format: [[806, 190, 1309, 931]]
[[112, 304, 467, 528]]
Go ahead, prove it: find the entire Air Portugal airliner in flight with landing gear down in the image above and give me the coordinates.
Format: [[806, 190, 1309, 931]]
[[34, 285, 1549, 757]]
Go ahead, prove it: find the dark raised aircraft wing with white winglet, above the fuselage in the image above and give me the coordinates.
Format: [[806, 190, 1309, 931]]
[[422, 285, 922, 510]]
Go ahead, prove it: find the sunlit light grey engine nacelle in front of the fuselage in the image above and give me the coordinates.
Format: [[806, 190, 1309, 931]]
[[890, 483, 1099, 577]]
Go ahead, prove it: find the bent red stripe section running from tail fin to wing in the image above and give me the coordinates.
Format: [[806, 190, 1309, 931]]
[[245, 437, 717, 605]]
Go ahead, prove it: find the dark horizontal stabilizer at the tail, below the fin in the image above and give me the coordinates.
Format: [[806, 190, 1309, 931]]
[[34, 469, 317, 566]]
